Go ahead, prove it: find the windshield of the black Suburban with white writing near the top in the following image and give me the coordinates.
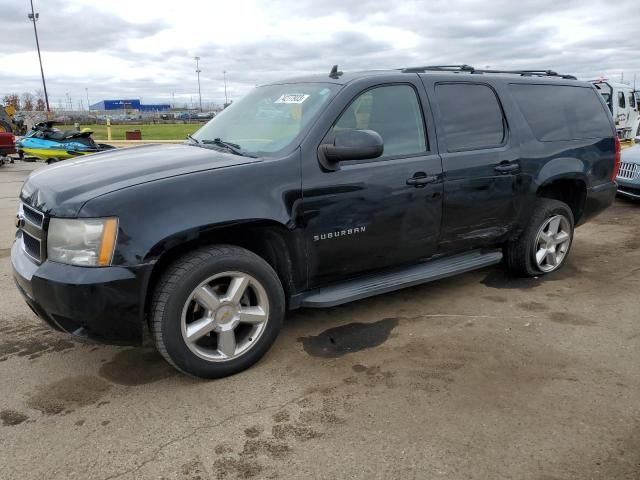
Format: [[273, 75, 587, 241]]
[[193, 83, 339, 154]]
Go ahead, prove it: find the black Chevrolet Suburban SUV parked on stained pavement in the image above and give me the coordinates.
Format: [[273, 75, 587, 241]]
[[11, 65, 619, 378]]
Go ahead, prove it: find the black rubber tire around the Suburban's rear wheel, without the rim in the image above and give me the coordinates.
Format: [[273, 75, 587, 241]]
[[504, 198, 575, 277]]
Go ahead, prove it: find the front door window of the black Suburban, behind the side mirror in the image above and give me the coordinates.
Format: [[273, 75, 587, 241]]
[[333, 85, 427, 157]]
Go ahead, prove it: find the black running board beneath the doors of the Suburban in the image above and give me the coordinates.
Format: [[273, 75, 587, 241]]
[[300, 250, 502, 308]]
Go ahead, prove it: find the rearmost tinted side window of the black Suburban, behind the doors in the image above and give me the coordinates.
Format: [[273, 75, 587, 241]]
[[510, 83, 613, 142]]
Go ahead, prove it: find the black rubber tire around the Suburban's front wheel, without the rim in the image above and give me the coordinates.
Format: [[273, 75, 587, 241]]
[[150, 245, 285, 379]]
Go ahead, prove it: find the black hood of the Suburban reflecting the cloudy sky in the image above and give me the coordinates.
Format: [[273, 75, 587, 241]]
[[20, 144, 261, 217]]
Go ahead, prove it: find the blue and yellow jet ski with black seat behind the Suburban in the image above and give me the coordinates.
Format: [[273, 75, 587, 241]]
[[16, 122, 114, 163]]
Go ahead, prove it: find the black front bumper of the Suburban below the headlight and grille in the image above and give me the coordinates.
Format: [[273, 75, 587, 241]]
[[11, 241, 153, 345]]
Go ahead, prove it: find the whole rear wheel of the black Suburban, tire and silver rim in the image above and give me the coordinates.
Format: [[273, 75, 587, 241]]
[[505, 198, 574, 276]]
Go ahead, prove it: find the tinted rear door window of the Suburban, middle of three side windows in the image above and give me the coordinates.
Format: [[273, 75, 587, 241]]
[[436, 83, 505, 152]]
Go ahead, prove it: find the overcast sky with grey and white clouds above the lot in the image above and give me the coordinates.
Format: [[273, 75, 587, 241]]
[[0, 0, 640, 108]]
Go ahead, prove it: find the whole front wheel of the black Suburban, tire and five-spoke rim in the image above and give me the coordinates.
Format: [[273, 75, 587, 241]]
[[150, 246, 285, 378]]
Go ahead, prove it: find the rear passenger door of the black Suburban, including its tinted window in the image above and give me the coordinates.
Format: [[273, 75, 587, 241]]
[[422, 76, 521, 250]]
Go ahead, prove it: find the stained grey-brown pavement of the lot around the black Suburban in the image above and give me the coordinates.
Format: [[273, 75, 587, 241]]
[[0, 162, 640, 480]]
